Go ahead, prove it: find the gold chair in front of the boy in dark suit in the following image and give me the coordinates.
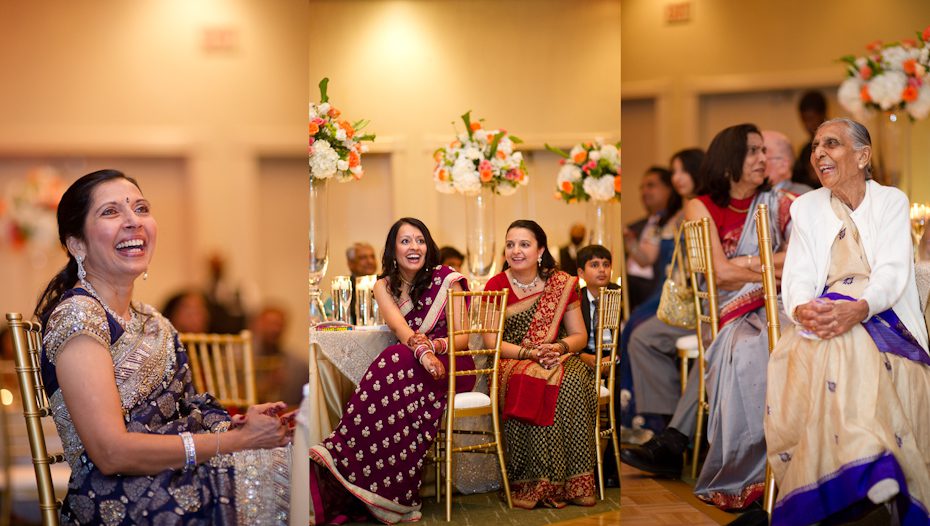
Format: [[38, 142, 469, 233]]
[[594, 287, 623, 500]]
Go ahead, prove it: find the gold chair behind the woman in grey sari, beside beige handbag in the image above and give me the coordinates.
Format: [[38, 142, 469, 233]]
[[683, 217, 719, 478]]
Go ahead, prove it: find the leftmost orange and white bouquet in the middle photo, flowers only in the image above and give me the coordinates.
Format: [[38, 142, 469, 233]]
[[310, 78, 375, 182]]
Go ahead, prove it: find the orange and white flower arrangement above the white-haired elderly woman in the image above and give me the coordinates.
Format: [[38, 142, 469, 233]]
[[837, 26, 930, 120]]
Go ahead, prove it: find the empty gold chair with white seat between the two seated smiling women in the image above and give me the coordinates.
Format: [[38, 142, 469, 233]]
[[434, 290, 513, 522]]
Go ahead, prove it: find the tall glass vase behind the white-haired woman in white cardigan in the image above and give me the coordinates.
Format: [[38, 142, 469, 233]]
[[872, 111, 913, 198]]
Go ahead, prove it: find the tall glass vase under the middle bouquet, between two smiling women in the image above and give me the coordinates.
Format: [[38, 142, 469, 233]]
[[465, 187, 497, 290]]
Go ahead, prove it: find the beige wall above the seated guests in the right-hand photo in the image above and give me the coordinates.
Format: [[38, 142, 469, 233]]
[[622, 0, 930, 225]]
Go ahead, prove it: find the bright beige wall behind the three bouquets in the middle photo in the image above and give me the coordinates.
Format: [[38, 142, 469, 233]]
[[309, 0, 620, 283]]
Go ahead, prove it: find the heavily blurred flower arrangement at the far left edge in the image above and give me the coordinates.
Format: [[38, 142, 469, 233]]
[[0, 166, 67, 254]]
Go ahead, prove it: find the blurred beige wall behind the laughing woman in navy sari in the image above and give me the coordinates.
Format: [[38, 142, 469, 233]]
[[0, 0, 308, 353]]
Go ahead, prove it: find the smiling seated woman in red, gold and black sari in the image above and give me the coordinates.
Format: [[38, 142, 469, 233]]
[[485, 220, 597, 509]]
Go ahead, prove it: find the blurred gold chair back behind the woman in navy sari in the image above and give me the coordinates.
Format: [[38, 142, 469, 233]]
[[179, 331, 258, 408]]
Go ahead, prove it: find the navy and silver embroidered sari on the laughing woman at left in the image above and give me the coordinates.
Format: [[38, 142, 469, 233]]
[[42, 289, 290, 525]]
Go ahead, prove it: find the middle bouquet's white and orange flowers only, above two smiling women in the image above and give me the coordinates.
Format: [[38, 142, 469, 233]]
[[433, 111, 529, 195]]
